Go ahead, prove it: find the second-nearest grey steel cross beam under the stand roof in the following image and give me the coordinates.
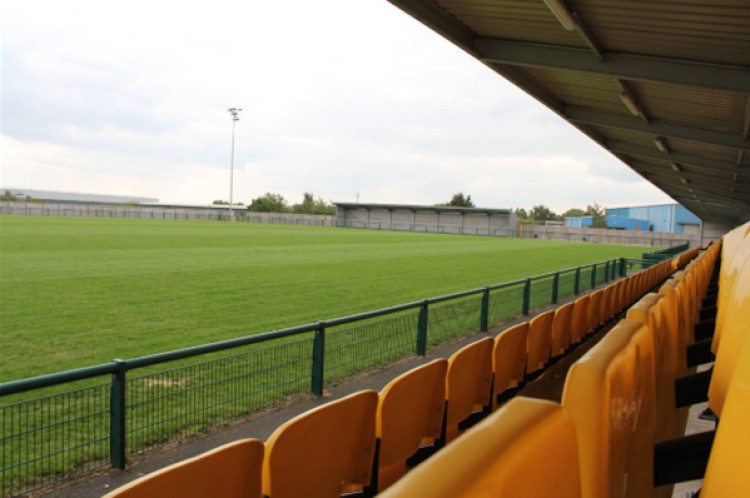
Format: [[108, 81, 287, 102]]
[[564, 105, 750, 150]]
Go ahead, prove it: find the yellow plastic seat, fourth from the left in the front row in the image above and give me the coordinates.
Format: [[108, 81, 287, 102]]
[[445, 337, 495, 443]]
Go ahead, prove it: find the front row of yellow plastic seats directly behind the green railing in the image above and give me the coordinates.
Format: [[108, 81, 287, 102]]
[[107, 253, 672, 498]]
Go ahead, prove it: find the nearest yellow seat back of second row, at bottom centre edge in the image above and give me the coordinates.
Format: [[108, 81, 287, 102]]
[[379, 397, 581, 498]]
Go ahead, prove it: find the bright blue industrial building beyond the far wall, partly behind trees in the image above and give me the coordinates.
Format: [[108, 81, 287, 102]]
[[565, 204, 701, 235]]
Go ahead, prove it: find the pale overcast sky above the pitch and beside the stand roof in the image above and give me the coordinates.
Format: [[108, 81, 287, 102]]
[[0, 0, 672, 212]]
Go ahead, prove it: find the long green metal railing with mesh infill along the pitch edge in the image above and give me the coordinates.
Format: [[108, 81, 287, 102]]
[[0, 258, 632, 496]]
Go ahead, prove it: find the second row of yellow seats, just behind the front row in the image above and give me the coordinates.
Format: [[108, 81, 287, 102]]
[[383, 239, 724, 498]]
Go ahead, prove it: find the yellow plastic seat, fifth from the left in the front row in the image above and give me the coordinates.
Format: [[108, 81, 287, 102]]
[[492, 322, 529, 410]]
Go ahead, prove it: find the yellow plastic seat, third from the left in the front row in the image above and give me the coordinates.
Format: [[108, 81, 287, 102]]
[[377, 359, 448, 491]]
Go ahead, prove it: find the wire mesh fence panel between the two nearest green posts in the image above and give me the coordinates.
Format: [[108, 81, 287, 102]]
[[127, 333, 313, 455]]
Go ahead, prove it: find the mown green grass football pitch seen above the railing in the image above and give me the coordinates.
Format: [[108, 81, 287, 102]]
[[0, 216, 652, 382]]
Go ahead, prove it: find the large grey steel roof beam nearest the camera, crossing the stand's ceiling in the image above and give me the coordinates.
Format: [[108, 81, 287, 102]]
[[474, 38, 750, 93]]
